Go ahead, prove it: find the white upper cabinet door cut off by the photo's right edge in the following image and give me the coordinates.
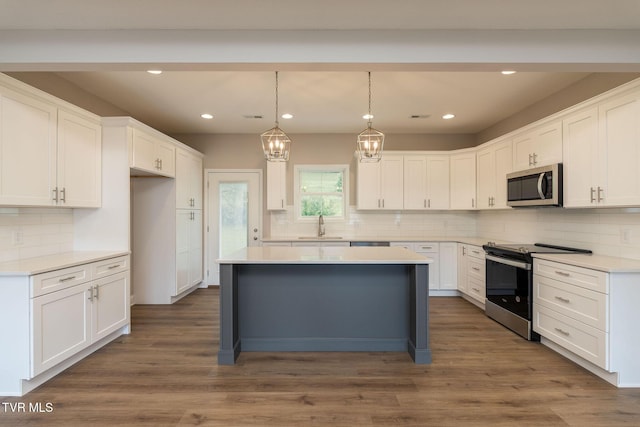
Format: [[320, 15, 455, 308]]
[[597, 91, 640, 206]]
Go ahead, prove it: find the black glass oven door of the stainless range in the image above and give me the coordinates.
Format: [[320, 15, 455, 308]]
[[486, 254, 533, 320]]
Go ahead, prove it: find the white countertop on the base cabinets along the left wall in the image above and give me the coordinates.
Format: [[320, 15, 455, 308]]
[[0, 251, 129, 276]]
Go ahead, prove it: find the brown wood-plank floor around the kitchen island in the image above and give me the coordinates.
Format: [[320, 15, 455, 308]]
[[0, 288, 640, 427]]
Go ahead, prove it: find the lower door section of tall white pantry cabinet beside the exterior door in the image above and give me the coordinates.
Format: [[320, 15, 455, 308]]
[[173, 209, 203, 295]]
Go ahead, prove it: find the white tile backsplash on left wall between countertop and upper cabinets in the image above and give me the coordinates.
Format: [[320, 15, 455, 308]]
[[0, 208, 73, 262]]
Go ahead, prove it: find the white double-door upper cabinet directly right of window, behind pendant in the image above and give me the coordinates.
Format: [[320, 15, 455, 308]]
[[356, 153, 404, 210]]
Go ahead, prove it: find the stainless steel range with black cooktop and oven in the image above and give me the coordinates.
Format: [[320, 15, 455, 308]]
[[482, 242, 591, 341]]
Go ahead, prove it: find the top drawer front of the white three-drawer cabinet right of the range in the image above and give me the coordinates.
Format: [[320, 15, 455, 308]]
[[533, 260, 609, 294]]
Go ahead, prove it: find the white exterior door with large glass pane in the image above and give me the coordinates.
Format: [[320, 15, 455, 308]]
[[205, 170, 262, 285]]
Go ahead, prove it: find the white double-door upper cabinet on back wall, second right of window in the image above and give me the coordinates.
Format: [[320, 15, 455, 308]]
[[403, 155, 449, 210]]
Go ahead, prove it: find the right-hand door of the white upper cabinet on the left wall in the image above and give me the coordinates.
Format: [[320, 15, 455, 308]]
[[57, 110, 102, 208]]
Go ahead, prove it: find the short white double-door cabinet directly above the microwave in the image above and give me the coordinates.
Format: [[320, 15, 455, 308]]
[[513, 120, 562, 171]]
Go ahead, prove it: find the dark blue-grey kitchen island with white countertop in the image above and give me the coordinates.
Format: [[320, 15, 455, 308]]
[[218, 247, 431, 365]]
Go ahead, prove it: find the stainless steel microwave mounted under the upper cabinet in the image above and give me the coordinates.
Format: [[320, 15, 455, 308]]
[[507, 163, 562, 207]]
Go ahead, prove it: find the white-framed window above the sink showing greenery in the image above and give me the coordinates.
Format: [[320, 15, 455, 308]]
[[294, 165, 349, 220]]
